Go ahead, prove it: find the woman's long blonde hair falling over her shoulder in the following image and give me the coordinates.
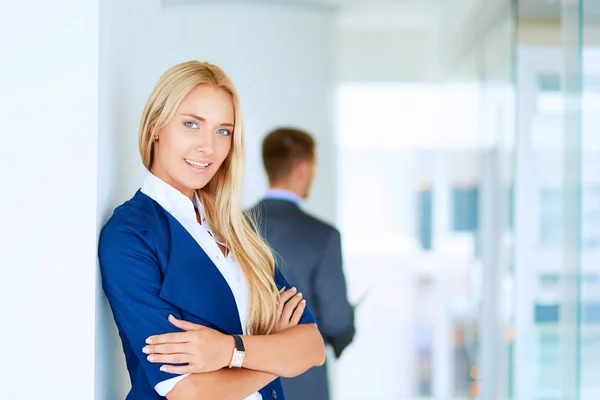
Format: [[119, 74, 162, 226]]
[[139, 61, 278, 334]]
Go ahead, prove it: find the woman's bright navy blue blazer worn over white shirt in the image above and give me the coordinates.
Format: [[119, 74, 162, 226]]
[[98, 190, 315, 400]]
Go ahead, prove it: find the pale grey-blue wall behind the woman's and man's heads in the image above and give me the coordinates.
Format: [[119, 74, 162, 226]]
[[158, 1, 336, 222]]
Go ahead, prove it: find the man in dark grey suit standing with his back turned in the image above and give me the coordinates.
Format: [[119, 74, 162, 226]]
[[252, 128, 354, 400]]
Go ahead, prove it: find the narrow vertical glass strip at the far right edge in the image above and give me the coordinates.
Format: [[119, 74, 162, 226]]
[[576, 0, 600, 400]]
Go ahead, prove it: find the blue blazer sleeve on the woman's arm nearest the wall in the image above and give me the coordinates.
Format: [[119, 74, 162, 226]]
[[98, 217, 186, 396]]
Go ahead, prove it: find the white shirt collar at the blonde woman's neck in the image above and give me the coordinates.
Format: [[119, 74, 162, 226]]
[[141, 172, 204, 220]]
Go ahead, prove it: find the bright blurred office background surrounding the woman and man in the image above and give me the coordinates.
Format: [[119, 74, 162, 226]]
[[0, 0, 600, 400]]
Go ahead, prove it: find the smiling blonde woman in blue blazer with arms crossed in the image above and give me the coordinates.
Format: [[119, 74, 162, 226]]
[[99, 61, 325, 400]]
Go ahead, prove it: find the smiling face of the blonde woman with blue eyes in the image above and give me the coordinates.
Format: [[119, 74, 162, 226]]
[[150, 85, 235, 198]]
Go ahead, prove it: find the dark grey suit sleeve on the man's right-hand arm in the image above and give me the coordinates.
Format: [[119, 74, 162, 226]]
[[313, 229, 355, 357]]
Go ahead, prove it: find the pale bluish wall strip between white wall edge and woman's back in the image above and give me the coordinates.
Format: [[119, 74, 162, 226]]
[[95, 0, 162, 400]]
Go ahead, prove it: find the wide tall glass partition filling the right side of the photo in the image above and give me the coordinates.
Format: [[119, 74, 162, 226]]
[[509, 0, 600, 400]]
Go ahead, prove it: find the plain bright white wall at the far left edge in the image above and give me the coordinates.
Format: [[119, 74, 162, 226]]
[[0, 0, 99, 400]]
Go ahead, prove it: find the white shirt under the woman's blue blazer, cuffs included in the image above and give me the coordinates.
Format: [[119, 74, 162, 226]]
[[141, 173, 262, 400]]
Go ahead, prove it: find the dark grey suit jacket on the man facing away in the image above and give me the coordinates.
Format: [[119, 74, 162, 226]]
[[251, 199, 354, 400]]
